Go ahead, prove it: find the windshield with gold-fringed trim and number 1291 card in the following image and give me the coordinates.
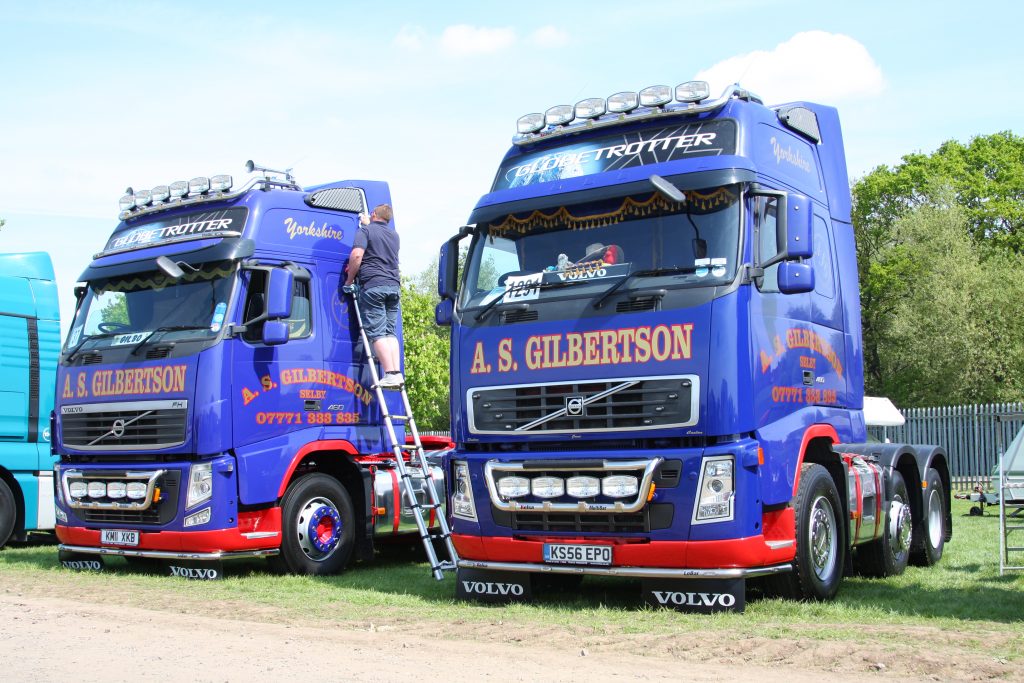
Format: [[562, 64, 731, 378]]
[[460, 185, 739, 308]]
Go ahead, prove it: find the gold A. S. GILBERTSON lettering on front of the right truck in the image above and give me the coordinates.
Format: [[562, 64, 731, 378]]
[[470, 323, 693, 375]]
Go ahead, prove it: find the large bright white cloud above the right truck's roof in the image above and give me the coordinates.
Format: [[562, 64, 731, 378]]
[[696, 31, 885, 103]]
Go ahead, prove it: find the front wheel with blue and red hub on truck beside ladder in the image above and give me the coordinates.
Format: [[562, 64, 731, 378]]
[[272, 473, 355, 577]]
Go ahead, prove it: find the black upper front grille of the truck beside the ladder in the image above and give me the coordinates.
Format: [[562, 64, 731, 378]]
[[60, 400, 188, 451]]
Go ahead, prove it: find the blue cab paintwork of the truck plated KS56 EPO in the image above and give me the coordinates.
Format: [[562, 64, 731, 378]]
[[449, 99, 866, 541]]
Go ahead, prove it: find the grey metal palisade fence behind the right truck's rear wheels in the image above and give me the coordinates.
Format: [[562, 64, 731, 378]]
[[868, 403, 1024, 489]]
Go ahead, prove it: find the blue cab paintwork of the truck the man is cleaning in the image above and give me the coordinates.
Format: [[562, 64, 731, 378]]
[[56, 180, 400, 530]]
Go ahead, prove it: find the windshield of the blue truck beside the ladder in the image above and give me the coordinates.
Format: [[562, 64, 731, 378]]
[[65, 261, 236, 349]]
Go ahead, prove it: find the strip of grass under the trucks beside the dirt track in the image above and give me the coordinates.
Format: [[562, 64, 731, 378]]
[[0, 501, 1024, 660]]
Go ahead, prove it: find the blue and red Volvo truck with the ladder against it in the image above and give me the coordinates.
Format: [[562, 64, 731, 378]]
[[54, 162, 440, 579]]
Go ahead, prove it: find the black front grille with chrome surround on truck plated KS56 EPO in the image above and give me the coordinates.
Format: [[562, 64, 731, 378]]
[[469, 376, 698, 434]]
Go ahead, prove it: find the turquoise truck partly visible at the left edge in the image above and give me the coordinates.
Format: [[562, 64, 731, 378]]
[[0, 252, 60, 548]]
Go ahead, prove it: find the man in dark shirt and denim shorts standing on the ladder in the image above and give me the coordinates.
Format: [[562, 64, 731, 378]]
[[345, 204, 404, 389]]
